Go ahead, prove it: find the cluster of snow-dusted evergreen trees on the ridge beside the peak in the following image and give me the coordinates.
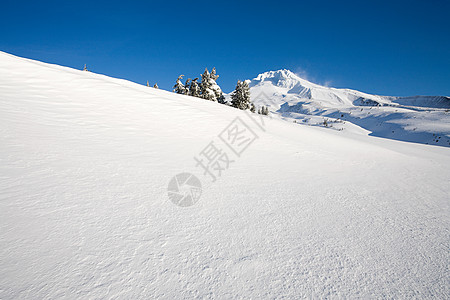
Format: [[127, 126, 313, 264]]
[[173, 68, 269, 115]]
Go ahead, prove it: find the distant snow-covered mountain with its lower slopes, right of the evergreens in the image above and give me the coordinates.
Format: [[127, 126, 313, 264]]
[[250, 70, 450, 147]]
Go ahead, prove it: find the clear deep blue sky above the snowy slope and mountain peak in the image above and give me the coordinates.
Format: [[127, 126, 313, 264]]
[[0, 0, 450, 96]]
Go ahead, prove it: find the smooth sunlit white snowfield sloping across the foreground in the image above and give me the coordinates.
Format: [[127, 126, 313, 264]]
[[0, 52, 450, 299]]
